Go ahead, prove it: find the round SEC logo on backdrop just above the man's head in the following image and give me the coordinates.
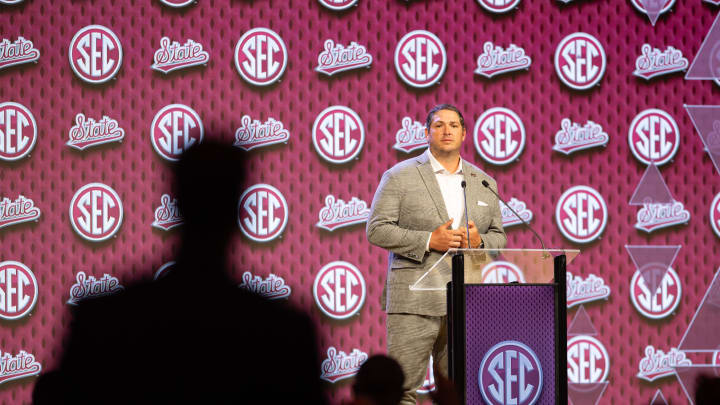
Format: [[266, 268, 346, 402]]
[[395, 30, 447, 88]]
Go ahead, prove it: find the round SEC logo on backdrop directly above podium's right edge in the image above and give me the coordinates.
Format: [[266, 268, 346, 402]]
[[555, 186, 608, 243]]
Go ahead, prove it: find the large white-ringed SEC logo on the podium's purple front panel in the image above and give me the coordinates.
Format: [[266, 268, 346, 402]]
[[478, 340, 543, 405]]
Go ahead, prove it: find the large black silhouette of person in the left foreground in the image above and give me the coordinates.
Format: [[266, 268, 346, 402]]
[[33, 141, 326, 405]]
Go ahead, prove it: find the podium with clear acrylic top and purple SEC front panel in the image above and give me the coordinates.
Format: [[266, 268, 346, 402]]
[[409, 249, 580, 405]]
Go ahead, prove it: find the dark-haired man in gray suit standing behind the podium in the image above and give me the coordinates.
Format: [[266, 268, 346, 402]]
[[367, 104, 507, 404]]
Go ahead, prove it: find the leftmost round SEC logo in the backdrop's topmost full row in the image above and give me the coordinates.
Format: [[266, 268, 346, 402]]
[[68, 25, 122, 84]]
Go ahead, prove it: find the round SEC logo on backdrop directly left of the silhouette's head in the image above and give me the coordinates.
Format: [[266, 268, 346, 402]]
[[70, 183, 123, 242]]
